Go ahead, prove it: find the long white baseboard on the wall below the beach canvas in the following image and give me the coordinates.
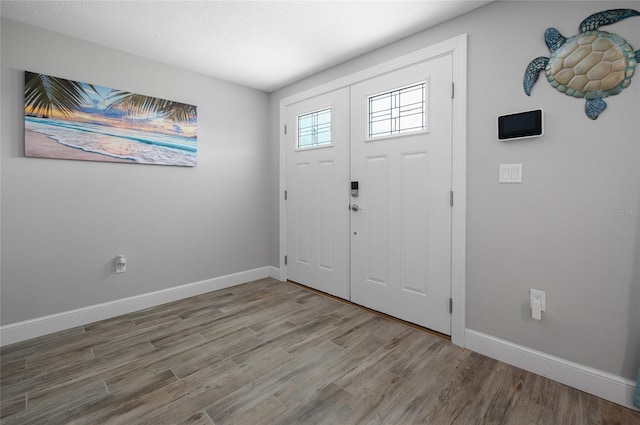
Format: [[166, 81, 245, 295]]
[[0, 266, 280, 346]]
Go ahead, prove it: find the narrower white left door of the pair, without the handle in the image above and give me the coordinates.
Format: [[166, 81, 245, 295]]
[[286, 88, 349, 299]]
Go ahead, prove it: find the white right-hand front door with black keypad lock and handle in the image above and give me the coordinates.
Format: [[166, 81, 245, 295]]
[[350, 54, 452, 335]]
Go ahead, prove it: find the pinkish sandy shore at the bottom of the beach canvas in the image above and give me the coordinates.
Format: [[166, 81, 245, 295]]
[[24, 129, 135, 163]]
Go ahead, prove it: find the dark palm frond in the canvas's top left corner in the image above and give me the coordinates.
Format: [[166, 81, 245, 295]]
[[24, 71, 95, 117]]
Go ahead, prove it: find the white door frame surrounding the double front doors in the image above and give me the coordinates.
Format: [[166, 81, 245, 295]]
[[278, 34, 467, 347]]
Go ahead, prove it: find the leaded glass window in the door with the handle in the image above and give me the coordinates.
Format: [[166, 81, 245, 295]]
[[369, 83, 427, 138]]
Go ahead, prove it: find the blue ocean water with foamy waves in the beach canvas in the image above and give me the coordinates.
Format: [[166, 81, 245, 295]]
[[25, 116, 197, 166]]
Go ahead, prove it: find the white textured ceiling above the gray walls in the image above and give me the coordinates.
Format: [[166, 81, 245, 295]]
[[0, 0, 489, 92]]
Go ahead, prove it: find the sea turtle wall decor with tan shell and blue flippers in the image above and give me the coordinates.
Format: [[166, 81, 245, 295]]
[[522, 9, 640, 120]]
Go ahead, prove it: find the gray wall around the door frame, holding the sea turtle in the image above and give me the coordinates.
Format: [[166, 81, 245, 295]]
[[270, 1, 640, 379]]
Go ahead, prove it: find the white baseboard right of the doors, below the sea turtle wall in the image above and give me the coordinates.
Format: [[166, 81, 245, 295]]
[[465, 329, 639, 410]]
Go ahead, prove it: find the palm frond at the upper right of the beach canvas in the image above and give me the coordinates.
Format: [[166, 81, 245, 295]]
[[107, 90, 196, 122]]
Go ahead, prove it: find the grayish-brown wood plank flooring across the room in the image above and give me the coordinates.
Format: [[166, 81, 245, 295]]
[[0, 279, 640, 425]]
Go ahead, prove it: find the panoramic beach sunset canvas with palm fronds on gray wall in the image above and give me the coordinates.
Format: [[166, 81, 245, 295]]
[[24, 71, 198, 167]]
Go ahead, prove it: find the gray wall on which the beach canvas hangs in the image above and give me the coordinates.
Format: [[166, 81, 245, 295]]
[[0, 20, 273, 325]]
